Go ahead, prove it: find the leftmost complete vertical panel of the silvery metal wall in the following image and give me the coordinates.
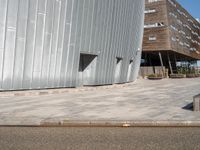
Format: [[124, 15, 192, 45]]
[[2, 0, 19, 90]]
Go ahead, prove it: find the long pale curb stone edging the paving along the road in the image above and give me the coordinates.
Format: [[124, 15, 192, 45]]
[[40, 120, 200, 127]]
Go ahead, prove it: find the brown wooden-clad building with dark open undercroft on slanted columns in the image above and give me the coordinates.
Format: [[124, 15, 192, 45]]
[[142, 0, 200, 73]]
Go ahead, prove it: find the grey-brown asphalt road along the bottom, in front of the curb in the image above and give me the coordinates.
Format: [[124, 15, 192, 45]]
[[0, 127, 200, 150]]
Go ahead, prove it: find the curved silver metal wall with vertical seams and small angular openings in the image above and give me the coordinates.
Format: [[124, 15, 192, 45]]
[[0, 0, 144, 90]]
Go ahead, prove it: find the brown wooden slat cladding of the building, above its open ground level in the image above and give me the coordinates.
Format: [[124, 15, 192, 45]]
[[143, 0, 200, 60]]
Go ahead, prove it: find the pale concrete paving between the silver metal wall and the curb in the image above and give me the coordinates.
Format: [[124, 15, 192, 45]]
[[0, 78, 200, 125]]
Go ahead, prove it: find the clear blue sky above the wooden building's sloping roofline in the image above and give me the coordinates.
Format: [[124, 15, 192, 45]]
[[177, 0, 200, 18]]
